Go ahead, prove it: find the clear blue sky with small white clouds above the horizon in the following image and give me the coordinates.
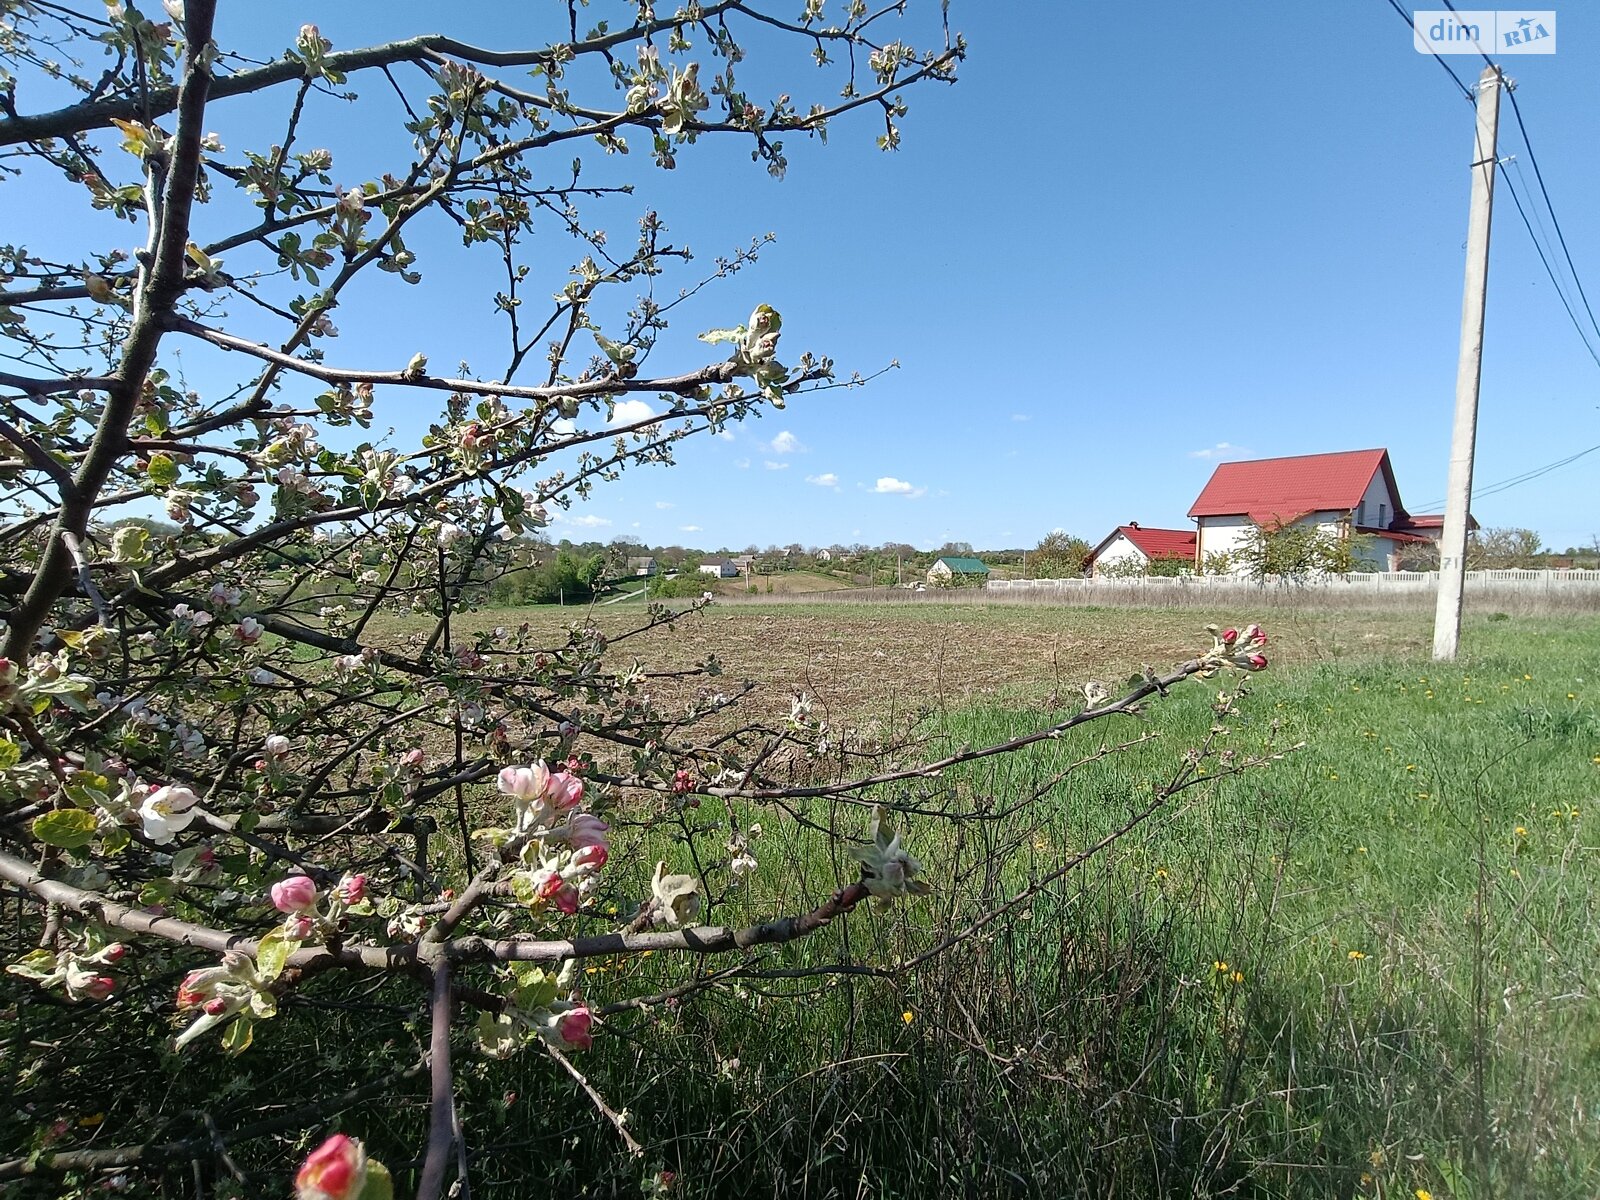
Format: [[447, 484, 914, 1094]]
[[12, 0, 1600, 547]]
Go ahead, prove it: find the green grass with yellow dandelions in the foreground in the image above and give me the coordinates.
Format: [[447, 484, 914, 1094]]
[[12, 610, 1600, 1200]]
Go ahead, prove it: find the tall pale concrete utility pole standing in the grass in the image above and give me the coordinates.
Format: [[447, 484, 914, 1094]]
[[1434, 67, 1510, 661]]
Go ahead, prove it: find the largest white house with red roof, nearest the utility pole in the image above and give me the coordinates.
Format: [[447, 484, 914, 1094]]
[[1189, 450, 1465, 571]]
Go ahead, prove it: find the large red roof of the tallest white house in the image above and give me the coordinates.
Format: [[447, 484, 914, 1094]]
[[1189, 450, 1405, 525]]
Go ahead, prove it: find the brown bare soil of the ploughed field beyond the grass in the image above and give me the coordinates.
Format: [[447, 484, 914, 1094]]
[[419, 605, 1429, 720]]
